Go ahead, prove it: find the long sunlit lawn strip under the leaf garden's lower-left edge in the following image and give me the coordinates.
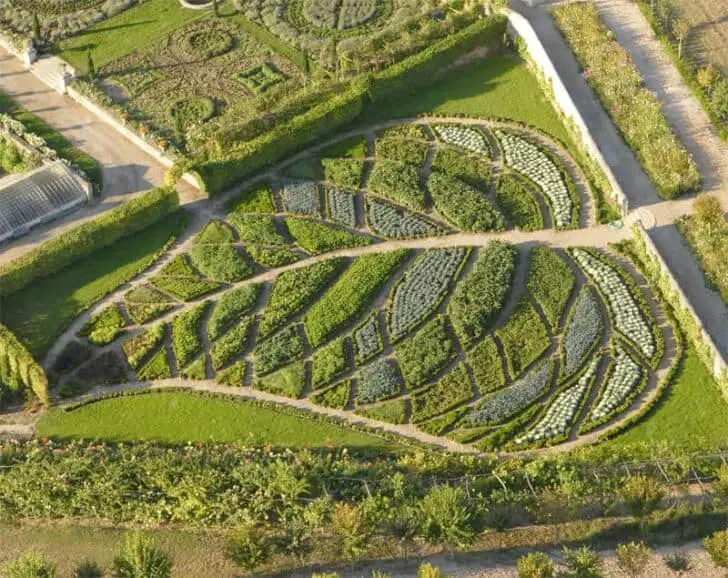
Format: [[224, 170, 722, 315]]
[[37, 392, 396, 451]]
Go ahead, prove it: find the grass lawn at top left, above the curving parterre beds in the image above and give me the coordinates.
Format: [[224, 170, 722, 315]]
[[57, 0, 209, 74]]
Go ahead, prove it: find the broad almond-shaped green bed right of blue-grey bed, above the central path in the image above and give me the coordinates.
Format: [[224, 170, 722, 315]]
[[427, 173, 505, 231]]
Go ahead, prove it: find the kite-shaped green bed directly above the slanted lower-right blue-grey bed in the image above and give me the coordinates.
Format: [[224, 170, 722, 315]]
[[495, 301, 551, 379]]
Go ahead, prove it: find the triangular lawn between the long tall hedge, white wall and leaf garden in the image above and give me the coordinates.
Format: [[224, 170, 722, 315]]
[[362, 54, 572, 146]]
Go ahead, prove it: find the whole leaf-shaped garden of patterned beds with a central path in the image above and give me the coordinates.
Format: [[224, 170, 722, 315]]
[[42, 119, 670, 451]]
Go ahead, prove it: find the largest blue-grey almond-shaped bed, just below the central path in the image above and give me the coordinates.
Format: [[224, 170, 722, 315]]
[[389, 248, 468, 340]]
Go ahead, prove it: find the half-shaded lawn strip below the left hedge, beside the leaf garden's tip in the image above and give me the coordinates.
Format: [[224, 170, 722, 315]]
[[0, 213, 185, 359]]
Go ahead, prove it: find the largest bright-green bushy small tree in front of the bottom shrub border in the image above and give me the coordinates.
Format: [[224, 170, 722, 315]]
[[420, 486, 475, 550]]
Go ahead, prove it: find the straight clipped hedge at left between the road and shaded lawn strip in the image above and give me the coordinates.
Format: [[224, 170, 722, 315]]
[[0, 187, 179, 297]]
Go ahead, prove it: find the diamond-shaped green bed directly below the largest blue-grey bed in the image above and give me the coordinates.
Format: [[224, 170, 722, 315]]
[[395, 316, 457, 388]]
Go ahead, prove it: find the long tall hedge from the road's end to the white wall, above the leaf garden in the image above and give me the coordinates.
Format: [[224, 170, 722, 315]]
[[193, 15, 506, 195]]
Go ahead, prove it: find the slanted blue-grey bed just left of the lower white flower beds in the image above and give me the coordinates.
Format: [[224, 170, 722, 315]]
[[468, 361, 554, 425]]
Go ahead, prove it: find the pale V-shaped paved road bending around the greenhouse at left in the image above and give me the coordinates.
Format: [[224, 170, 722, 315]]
[[0, 48, 199, 263]]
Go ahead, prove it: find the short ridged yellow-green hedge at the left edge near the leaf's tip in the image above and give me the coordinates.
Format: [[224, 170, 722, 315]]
[[0, 324, 48, 405]]
